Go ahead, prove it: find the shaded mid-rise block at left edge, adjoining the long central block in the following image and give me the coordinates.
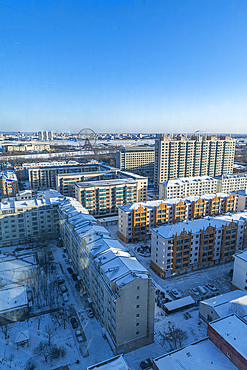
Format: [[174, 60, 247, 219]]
[[0, 190, 61, 246]]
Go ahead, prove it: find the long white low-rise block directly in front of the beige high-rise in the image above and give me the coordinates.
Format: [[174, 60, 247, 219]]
[[159, 173, 247, 199]]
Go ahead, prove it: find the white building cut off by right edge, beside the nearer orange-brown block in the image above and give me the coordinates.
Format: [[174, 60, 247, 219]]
[[232, 250, 247, 291]]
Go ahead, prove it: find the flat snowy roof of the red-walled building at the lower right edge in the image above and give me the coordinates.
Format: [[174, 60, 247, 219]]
[[209, 315, 247, 360]]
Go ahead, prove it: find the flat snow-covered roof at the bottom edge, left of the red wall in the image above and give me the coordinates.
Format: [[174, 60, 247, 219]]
[[154, 338, 237, 370]]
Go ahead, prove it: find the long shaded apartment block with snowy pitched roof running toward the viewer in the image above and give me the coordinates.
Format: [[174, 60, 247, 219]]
[[59, 200, 155, 355]]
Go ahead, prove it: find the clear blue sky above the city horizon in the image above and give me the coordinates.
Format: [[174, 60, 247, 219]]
[[0, 0, 247, 133]]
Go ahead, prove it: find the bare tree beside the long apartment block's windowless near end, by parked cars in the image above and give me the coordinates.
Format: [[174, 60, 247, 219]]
[[158, 323, 188, 350]]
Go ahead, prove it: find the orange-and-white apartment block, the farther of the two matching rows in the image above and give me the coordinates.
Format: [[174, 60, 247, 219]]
[[118, 193, 235, 242]]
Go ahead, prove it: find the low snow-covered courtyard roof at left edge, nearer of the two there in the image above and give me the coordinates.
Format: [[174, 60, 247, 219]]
[[0, 286, 28, 314]]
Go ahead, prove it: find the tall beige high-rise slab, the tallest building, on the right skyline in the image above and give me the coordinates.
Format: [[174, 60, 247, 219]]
[[154, 135, 235, 189]]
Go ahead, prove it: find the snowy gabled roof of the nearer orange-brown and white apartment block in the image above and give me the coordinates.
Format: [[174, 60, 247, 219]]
[[151, 211, 247, 239]]
